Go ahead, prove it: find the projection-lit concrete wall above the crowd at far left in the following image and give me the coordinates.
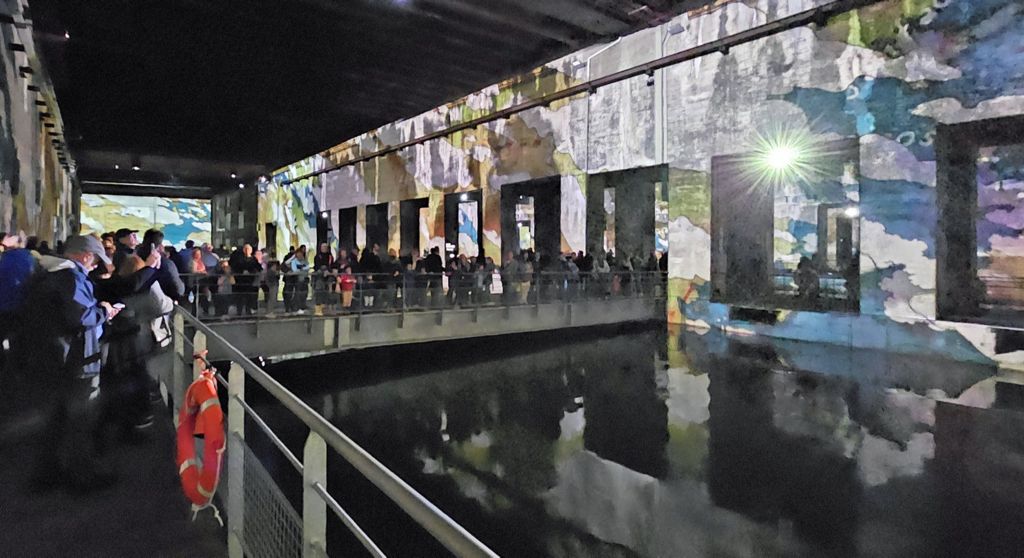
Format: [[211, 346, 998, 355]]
[[0, 0, 78, 239]]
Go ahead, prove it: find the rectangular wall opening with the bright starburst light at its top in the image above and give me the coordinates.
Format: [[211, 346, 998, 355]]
[[712, 139, 860, 311]]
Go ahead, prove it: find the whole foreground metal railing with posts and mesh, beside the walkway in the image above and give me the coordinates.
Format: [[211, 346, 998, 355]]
[[164, 307, 497, 558]]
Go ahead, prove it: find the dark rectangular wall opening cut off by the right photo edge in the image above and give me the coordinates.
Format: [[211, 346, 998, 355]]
[[936, 117, 1024, 326]]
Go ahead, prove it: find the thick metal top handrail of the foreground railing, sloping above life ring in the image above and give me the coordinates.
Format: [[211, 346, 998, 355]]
[[174, 306, 498, 557]]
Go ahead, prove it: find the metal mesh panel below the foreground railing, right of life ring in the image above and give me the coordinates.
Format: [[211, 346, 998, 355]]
[[228, 436, 302, 558]]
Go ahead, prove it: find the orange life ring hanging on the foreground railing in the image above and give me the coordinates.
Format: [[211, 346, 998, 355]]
[[177, 370, 224, 506]]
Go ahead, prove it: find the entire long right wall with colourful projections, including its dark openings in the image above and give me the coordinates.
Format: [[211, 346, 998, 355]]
[[260, 0, 1024, 367]]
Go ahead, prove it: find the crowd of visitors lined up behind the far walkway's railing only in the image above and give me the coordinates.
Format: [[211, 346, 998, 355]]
[[178, 243, 668, 316]]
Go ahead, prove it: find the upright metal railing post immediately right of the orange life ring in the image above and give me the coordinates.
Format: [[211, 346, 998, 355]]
[[227, 362, 246, 558]]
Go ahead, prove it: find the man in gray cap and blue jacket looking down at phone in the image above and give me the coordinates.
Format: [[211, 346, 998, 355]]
[[27, 235, 119, 489]]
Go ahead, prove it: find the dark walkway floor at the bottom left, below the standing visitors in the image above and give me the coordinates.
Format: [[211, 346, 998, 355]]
[[0, 407, 227, 557]]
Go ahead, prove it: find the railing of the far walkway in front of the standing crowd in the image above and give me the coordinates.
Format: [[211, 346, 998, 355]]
[[176, 269, 667, 320]]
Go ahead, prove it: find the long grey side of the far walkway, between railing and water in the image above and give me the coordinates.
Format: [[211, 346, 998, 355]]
[[200, 299, 665, 360]]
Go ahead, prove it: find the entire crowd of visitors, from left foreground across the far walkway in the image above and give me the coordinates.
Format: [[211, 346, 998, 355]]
[[0, 228, 667, 490]]
